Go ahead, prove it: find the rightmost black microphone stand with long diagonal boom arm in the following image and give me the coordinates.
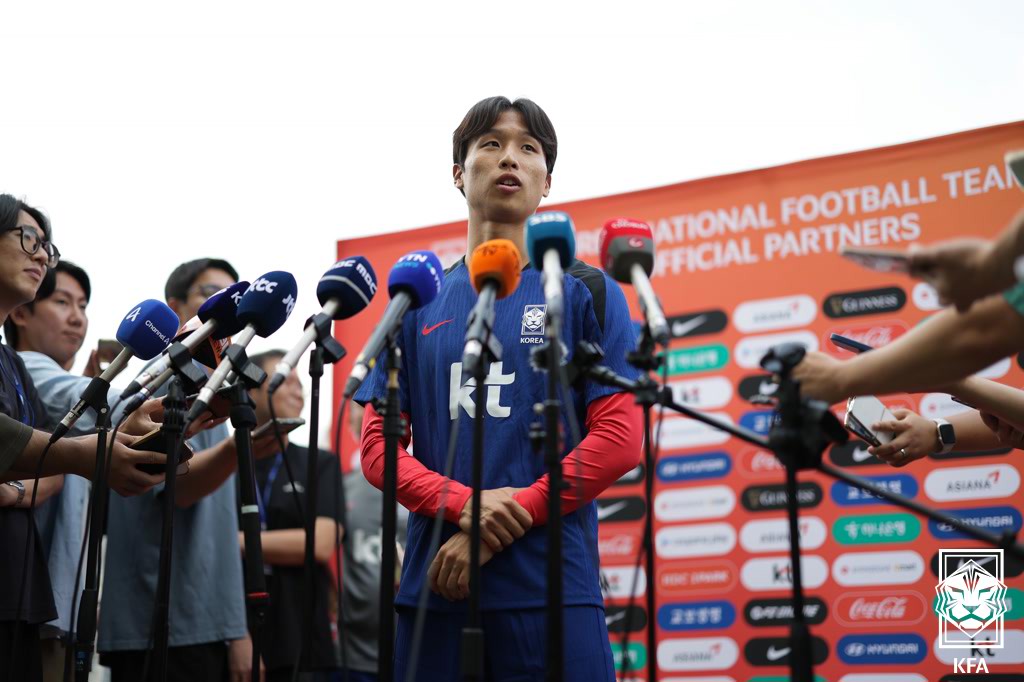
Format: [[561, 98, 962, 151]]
[[573, 341, 1024, 682]]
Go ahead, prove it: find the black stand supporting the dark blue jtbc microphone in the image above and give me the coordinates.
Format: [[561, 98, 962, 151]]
[[221, 345, 272, 682]]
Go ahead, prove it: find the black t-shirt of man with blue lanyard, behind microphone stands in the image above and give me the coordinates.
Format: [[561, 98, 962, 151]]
[[248, 444, 343, 670]]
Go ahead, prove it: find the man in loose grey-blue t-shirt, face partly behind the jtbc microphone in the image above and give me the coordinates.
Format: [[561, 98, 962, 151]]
[[97, 258, 279, 682]]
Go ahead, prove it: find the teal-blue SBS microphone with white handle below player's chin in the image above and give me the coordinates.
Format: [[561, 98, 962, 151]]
[[526, 211, 575, 339]]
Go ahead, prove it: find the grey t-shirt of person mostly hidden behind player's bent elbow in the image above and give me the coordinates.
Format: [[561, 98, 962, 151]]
[[342, 465, 409, 673]]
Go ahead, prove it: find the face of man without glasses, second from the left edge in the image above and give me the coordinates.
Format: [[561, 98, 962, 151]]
[[11, 272, 89, 370]]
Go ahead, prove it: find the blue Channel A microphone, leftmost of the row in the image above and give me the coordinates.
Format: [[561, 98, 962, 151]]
[[50, 298, 178, 443]]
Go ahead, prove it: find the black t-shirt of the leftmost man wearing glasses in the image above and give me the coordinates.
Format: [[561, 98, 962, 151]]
[[0, 343, 57, 624]]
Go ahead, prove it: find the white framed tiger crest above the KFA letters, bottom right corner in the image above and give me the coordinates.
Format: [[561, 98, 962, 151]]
[[935, 549, 1008, 649]]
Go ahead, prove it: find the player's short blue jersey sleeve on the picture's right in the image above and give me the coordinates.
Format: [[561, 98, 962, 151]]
[[584, 272, 640, 404]]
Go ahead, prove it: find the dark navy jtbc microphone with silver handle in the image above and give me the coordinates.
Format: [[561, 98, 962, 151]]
[[185, 270, 298, 424]]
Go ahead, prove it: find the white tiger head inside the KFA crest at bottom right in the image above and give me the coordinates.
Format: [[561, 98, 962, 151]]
[[935, 559, 1007, 640]]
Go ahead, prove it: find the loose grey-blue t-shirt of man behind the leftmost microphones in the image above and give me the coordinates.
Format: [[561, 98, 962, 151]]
[[97, 366, 246, 651]]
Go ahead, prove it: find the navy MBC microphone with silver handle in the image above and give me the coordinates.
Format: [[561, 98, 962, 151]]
[[269, 256, 377, 393]]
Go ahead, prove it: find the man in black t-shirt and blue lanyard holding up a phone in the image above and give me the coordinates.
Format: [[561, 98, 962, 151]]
[[239, 350, 343, 682]]
